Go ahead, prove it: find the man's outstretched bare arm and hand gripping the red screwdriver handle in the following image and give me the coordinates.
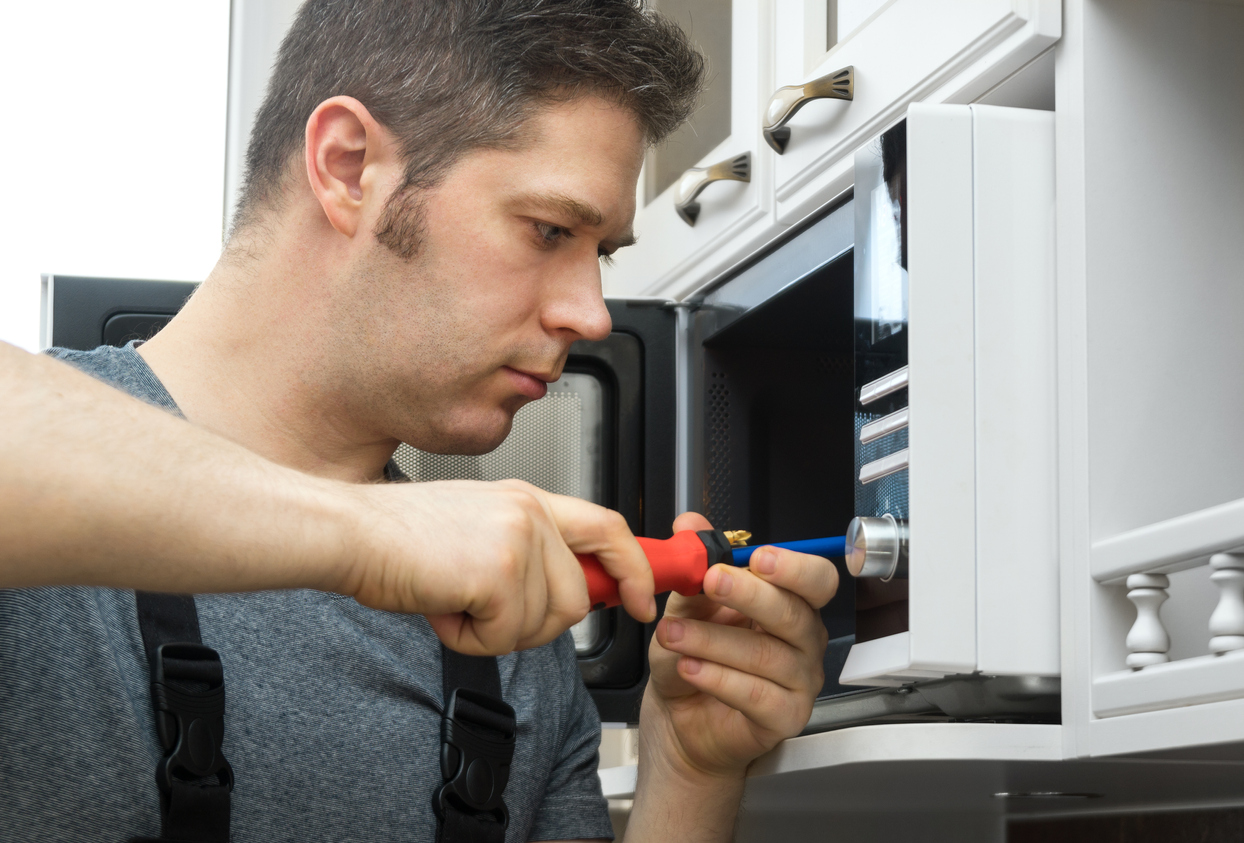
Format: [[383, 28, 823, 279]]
[[0, 343, 656, 654]]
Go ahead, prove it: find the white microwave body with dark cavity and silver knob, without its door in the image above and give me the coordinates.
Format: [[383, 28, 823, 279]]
[[651, 104, 1060, 731]]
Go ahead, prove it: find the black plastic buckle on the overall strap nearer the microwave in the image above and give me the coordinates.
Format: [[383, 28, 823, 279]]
[[432, 688, 515, 831]]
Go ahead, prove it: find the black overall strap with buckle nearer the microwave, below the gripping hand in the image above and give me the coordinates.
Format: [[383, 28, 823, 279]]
[[432, 645, 515, 843]]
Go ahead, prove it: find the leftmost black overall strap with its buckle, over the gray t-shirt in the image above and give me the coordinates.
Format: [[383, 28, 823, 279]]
[[131, 592, 233, 843]]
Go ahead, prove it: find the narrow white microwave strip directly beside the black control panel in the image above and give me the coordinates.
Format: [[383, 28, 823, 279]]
[[907, 104, 977, 674]]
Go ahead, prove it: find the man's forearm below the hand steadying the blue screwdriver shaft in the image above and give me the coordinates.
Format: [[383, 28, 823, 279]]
[[624, 715, 744, 843]]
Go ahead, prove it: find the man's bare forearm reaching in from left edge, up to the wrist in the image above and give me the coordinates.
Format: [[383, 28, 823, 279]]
[[0, 343, 348, 592]]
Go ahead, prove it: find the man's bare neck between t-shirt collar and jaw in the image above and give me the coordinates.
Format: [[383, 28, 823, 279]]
[[138, 234, 397, 482]]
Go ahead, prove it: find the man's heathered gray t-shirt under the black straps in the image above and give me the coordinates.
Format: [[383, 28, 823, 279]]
[[0, 347, 612, 843]]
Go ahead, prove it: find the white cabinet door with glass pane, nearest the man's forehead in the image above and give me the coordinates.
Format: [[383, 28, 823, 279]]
[[605, 0, 773, 297]]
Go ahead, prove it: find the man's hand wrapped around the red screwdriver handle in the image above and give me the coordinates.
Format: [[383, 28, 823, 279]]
[[332, 480, 657, 655]]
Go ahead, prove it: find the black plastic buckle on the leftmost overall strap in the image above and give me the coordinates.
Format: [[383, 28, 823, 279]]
[[152, 642, 234, 798]]
